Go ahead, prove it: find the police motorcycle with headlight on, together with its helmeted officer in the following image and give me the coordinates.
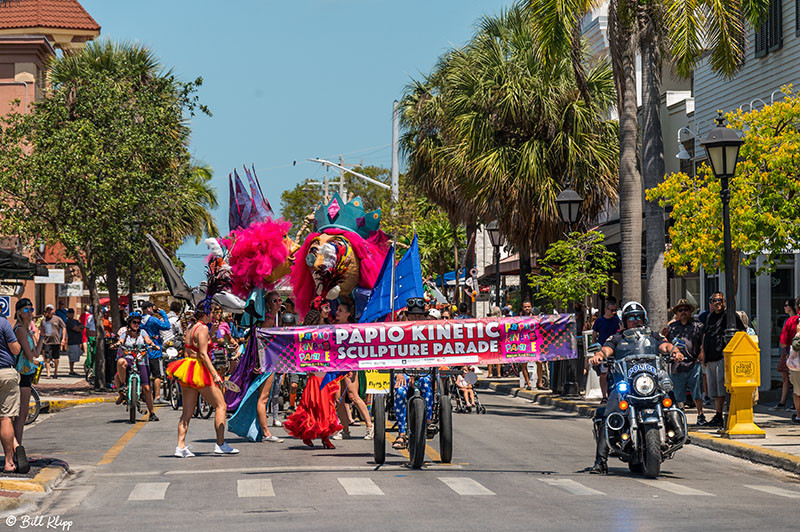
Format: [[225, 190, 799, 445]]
[[589, 303, 688, 478]]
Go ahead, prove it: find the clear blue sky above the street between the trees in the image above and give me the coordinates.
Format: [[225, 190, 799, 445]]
[[80, 0, 512, 284]]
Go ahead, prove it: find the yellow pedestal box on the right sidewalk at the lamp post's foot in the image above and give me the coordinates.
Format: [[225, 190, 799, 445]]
[[722, 331, 767, 438]]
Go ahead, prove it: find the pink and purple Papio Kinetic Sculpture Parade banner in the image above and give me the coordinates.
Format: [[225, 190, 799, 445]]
[[258, 314, 577, 373]]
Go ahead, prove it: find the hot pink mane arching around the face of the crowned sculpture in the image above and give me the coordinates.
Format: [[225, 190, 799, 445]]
[[291, 228, 389, 316]]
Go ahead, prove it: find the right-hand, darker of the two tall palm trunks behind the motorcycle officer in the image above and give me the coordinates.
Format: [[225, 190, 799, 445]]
[[640, 26, 668, 331]]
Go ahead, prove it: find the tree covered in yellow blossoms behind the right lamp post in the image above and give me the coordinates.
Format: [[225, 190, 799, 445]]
[[647, 85, 800, 275]]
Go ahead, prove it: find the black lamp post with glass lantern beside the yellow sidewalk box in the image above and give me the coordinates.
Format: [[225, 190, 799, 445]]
[[700, 113, 744, 341]]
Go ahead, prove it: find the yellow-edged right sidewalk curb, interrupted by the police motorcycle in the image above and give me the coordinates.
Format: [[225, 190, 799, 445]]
[[478, 381, 800, 474]]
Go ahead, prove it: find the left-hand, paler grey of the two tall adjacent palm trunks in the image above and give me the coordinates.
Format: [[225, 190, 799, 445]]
[[608, 0, 642, 302]]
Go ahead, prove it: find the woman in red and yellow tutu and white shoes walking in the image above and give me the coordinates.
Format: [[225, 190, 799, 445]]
[[167, 304, 239, 458]]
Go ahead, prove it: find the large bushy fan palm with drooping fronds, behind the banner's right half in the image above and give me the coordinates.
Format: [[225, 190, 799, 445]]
[[403, 7, 618, 297]]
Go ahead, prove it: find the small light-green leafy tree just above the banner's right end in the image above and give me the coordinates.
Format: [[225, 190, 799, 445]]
[[530, 231, 616, 309]]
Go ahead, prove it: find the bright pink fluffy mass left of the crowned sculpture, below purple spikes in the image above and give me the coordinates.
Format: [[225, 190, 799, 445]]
[[224, 218, 292, 298]]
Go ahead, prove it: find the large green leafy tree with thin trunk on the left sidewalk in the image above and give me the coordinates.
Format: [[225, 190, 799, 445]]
[[0, 42, 209, 385]]
